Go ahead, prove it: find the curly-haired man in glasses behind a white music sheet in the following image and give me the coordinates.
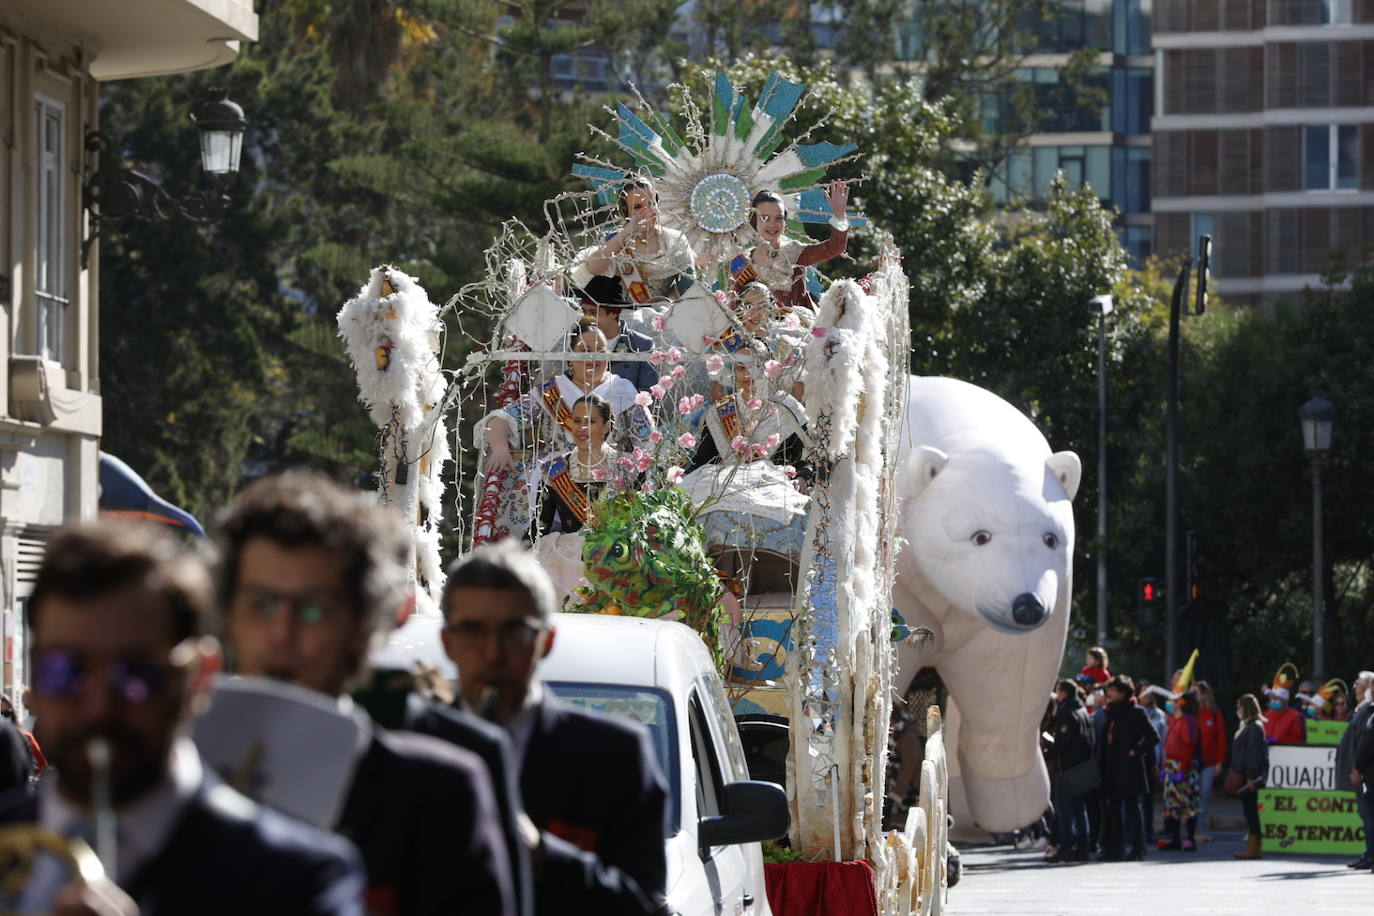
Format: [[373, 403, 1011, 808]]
[[218, 472, 514, 916]]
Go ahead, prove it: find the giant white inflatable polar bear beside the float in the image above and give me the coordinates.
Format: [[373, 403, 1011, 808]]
[[893, 376, 1083, 832]]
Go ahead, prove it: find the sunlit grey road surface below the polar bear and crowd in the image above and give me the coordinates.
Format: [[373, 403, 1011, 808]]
[[945, 831, 1374, 916]]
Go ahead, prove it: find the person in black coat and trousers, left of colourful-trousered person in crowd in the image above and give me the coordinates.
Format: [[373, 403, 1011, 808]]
[[1098, 674, 1160, 862]]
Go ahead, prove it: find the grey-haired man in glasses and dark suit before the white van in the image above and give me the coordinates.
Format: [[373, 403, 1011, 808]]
[[425, 541, 668, 916]]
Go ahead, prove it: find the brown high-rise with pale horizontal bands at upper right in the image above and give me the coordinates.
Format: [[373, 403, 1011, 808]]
[[1151, 0, 1374, 304]]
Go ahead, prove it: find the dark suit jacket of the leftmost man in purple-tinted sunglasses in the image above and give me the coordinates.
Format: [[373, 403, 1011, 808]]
[[0, 777, 364, 916]]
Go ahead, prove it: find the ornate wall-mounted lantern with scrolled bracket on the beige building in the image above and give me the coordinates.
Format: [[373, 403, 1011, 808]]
[[81, 89, 247, 269]]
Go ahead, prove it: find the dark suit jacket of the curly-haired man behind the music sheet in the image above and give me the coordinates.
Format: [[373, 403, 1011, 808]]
[[338, 728, 515, 916]]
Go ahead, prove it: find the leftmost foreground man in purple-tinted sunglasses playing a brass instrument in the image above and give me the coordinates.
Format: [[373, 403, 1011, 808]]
[[8, 522, 363, 916]]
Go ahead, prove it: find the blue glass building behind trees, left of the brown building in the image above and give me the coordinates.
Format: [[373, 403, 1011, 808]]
[[896, 0, 1156, 258]]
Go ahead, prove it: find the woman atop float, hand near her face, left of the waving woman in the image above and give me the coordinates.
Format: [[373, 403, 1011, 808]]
[[573, 177, 697, 305]]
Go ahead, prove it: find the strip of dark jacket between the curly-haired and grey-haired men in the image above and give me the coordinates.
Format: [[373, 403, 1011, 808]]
[[407, 698, 534, 916]]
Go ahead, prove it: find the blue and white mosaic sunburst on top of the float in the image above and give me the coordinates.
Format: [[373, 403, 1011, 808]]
[[573, 71, 867, 271]]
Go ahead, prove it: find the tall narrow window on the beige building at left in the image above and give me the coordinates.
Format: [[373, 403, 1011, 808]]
[[33, 96, 67, 363]]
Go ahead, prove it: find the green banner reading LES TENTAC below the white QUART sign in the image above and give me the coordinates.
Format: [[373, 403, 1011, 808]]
[[1260, 788, 1364, 856]]
